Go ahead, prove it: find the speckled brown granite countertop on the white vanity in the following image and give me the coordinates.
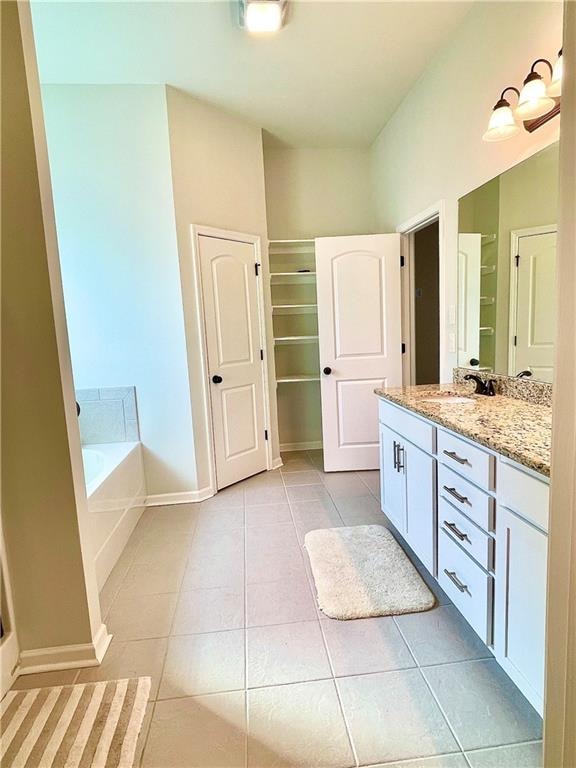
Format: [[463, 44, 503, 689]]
[[374, 384, 552, 477]]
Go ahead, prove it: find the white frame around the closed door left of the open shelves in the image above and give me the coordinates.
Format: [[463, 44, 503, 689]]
[[191, 224, 272, 495]]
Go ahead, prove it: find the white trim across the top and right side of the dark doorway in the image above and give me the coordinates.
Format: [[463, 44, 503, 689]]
[[396, 200, 458, 382]]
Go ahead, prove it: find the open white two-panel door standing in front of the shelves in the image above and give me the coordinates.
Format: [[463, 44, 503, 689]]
[[316, 234, 402, 472]]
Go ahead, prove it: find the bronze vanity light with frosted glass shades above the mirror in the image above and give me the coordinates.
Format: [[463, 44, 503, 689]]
[[482, 50, 563, 141]]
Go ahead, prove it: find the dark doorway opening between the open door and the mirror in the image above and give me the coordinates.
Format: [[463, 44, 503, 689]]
[[410, 219, 440, 384]]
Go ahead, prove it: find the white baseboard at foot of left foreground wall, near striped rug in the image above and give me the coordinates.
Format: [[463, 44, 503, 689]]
[[18, 624, 112, 675]]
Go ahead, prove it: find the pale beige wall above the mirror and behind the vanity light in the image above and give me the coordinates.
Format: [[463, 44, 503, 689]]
[[372, 2, 562, 230]]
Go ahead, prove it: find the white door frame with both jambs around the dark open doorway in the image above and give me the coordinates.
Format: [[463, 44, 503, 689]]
[[396, 199, 458, 386]]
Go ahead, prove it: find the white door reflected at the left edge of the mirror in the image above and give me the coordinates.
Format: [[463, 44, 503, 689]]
[[458, 232, 482, 368]]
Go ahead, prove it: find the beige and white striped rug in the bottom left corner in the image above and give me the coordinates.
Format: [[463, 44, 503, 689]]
[[0, 677, 150, 768]]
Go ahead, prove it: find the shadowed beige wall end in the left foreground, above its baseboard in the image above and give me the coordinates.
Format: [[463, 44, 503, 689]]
[[0, 2, 99, 651]]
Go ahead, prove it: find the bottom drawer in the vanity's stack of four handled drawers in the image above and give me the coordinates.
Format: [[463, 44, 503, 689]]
[[438, 530, 493, 645]]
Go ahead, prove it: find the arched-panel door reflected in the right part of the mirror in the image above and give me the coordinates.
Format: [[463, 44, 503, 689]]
[[509, 232, 556, 381]]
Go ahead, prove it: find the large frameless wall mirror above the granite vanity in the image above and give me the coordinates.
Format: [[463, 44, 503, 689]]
[[458, 143, 558, 381]]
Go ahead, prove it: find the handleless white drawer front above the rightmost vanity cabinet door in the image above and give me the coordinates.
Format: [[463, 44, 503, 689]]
[[498, 458, 550, 531]]
